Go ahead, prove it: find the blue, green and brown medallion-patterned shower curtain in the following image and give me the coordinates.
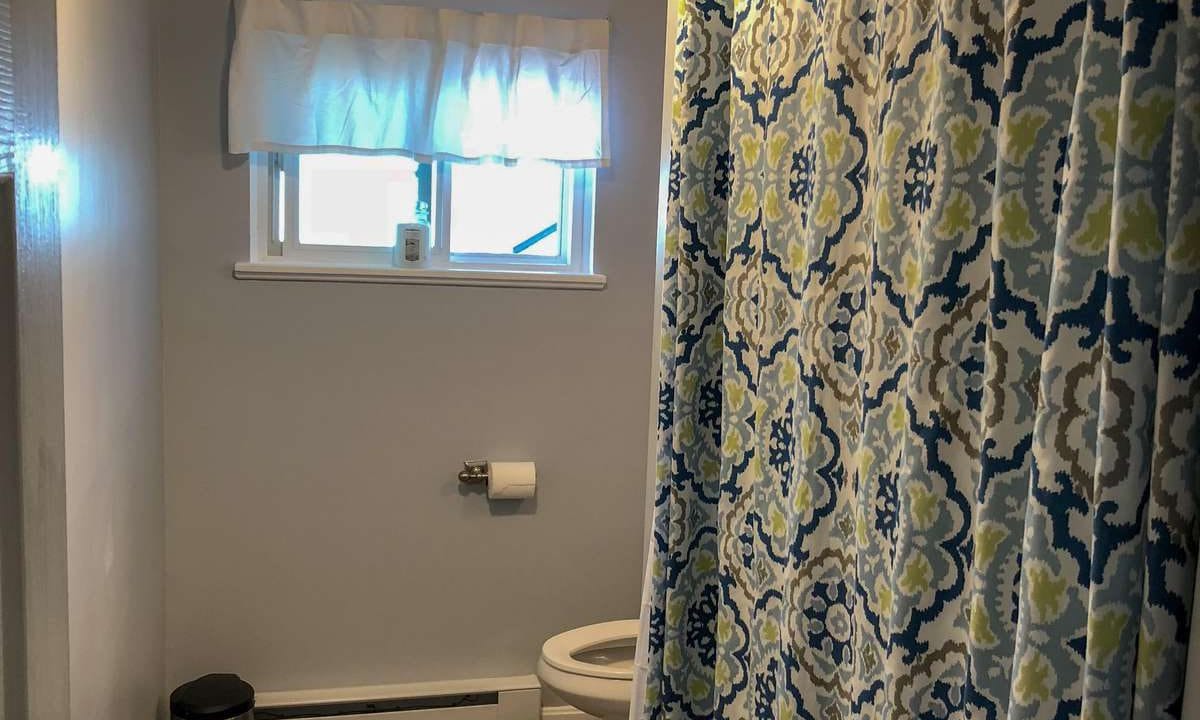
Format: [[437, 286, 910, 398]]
[[635, 0, 1200, 720]]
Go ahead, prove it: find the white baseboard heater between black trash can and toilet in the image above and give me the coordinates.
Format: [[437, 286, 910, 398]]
[[254, 676, 541, 720]]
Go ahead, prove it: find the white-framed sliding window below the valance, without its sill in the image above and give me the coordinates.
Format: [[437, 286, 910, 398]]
[[252, 154, 594, 280]]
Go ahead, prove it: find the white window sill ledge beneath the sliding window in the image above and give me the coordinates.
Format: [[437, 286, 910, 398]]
[[233, 263, 608, 290]]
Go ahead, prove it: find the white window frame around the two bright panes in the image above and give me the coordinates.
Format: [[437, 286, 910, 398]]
[[250, 152, 595, 276]]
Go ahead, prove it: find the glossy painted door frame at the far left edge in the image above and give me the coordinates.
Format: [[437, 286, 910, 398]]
[[4, 0, 70, 720]]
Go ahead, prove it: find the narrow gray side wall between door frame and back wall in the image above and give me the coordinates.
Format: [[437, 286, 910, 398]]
[[58, 0, 163, 720]]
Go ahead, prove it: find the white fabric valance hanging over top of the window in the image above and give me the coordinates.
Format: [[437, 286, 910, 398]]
[[229, 0, 608, 167]]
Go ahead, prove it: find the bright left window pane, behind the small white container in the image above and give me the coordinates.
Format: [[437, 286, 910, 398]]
[[298, 155, 431, 247]]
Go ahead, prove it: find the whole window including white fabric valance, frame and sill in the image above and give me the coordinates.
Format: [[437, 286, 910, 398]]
[[227, 0, 612, 288]]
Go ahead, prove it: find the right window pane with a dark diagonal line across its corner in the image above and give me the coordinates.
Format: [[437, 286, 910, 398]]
[[450, 164, 565, 258]]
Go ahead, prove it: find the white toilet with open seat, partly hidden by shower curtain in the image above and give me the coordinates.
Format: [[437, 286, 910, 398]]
[[538, 620, 638, 720]]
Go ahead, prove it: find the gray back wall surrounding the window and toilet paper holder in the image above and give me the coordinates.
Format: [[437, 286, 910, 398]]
[[157, 0, 666, 690]]
